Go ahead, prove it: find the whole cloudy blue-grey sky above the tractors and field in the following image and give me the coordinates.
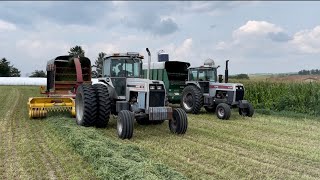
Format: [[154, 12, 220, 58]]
[[0, 1, 320, 76]]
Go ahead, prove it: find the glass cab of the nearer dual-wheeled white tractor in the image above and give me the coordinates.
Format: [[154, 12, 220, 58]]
[[102, 52, 143, 98]]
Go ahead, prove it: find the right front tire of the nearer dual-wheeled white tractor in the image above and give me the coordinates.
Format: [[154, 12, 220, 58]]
[[169, 108, 188, 134]]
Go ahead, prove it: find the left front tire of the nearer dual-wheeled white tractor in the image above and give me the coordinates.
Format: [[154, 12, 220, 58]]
[[117, 110, 134, 139]]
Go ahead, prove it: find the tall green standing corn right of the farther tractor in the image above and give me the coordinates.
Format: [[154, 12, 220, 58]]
[[242, 81, 320, 115]]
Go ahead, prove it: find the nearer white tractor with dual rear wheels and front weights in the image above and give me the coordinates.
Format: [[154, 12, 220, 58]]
[[76, 48, 188, 139]]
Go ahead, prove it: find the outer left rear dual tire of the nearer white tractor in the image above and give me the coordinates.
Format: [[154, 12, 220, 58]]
[[76, 84, 97, 126]]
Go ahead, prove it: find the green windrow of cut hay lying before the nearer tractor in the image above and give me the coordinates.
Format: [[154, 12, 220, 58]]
[[48, 117, 186, 179]]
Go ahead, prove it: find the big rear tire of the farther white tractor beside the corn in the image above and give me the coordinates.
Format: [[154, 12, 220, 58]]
[[180, 85, 203, 114]]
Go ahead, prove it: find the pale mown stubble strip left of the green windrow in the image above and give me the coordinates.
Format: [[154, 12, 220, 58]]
[[0, 86, 96, 179]]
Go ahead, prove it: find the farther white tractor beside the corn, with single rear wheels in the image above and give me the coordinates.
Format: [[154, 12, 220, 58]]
[[180, 59, 254, 120]]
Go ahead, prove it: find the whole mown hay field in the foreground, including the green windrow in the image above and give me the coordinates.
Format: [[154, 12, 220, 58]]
[[0, 86, 320, 179]]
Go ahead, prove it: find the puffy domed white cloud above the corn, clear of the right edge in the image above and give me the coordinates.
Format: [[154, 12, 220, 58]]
[[215, 21, 292, 57]]
